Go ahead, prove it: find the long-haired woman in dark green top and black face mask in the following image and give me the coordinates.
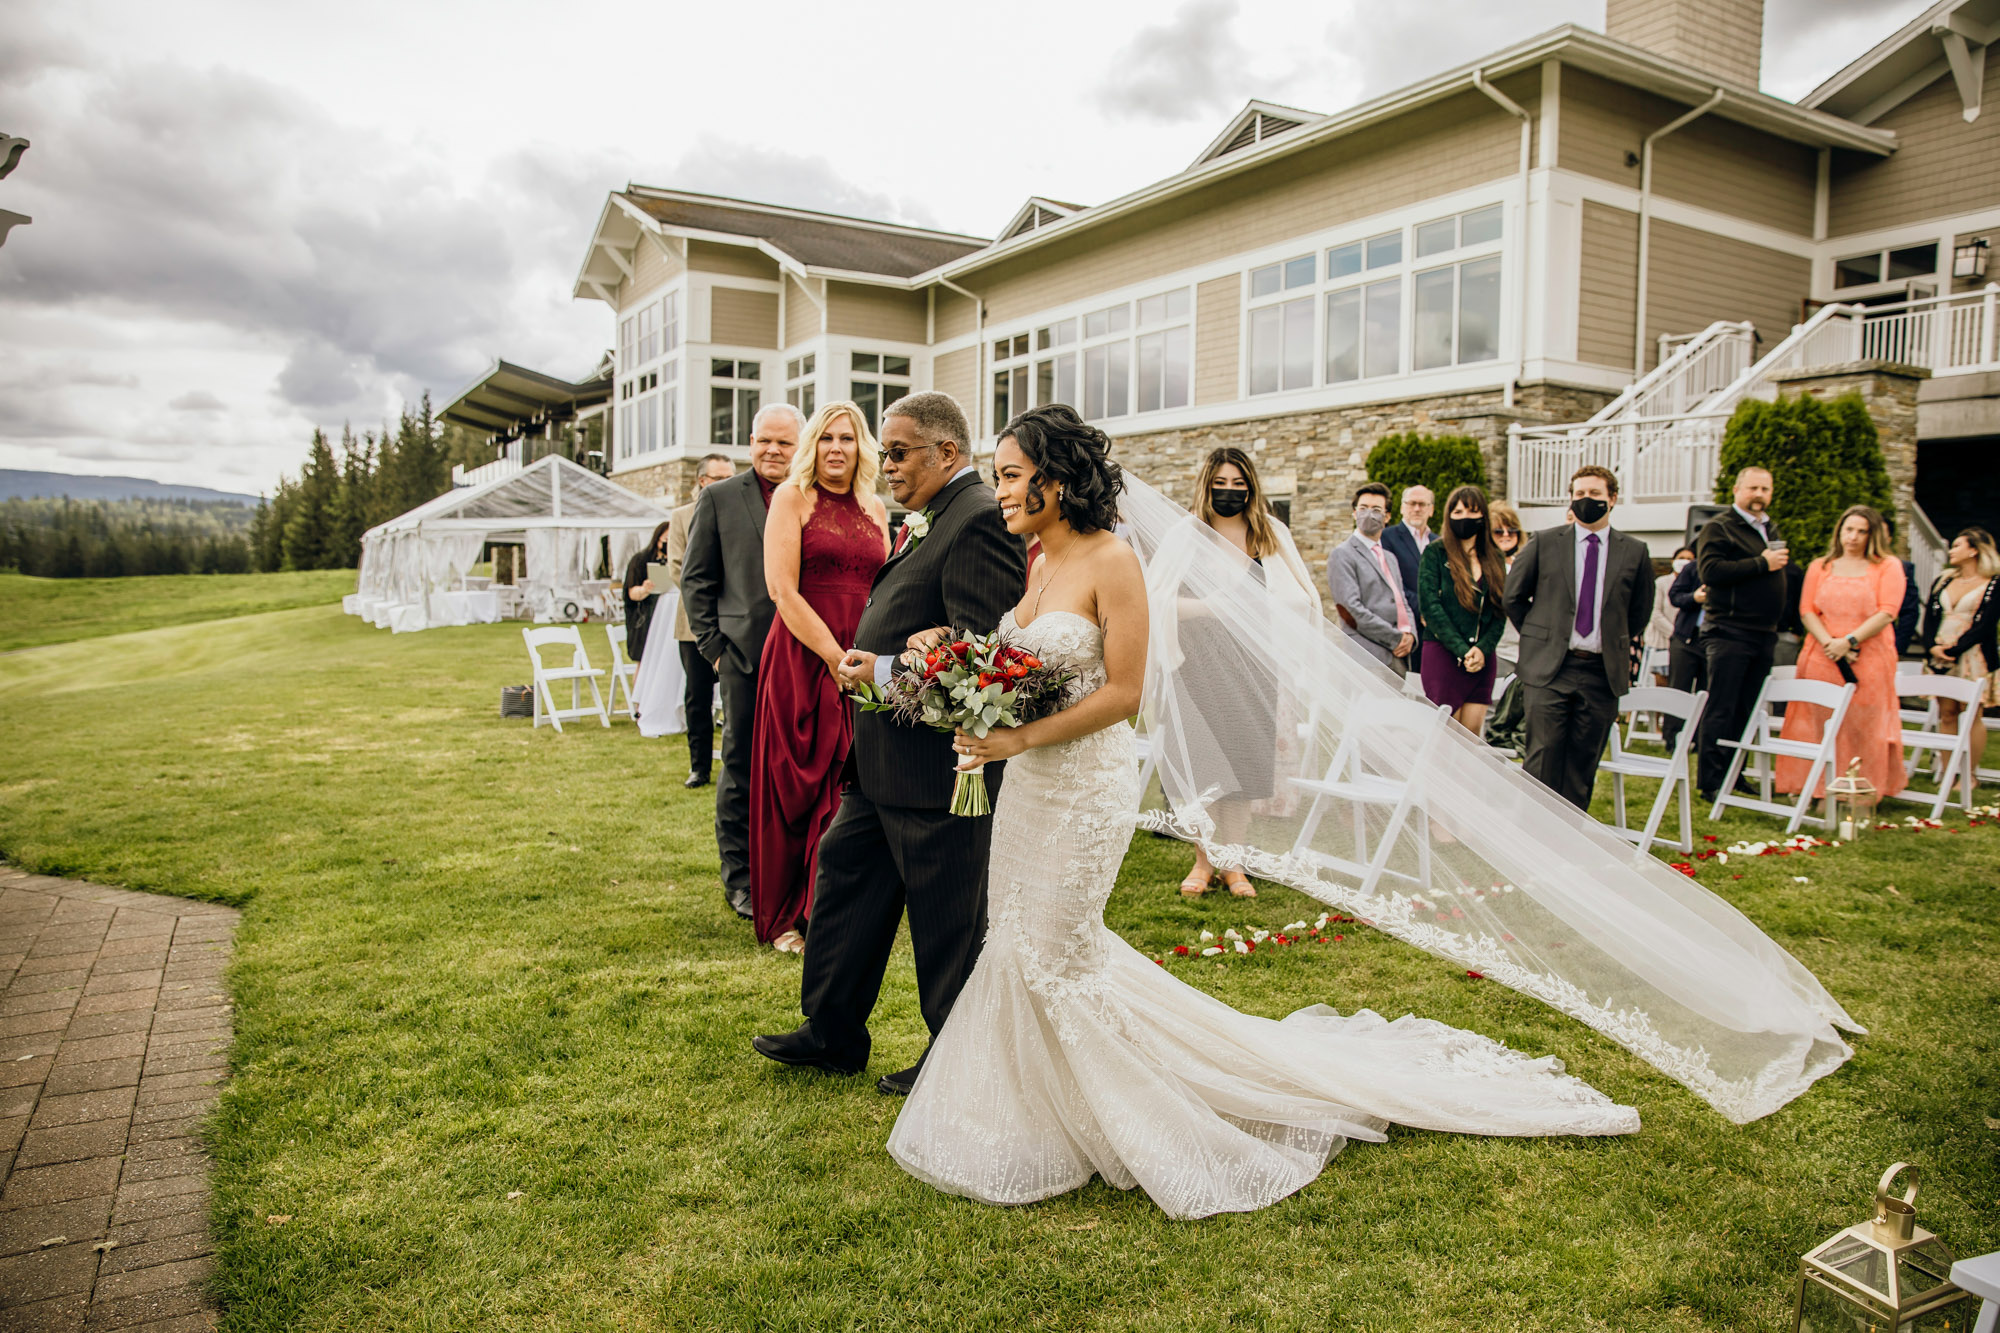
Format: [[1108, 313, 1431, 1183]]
[[1416, 486, 1506, 737]]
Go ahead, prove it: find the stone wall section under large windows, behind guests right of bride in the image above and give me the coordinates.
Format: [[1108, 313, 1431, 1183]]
[[1112, 384, 1616, 564]]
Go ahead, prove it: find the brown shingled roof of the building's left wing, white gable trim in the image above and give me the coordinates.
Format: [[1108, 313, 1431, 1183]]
[[576, 184, 988, 302]]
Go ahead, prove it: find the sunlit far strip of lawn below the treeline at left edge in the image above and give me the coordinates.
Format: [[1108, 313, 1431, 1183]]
[[0, 568, 354, 652]]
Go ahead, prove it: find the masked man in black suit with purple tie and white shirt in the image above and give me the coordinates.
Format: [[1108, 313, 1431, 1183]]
[[1506, 464, 1656, 811]]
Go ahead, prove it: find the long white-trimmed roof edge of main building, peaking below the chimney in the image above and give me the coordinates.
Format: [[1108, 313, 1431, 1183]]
[[912, 26, 1896, 286]]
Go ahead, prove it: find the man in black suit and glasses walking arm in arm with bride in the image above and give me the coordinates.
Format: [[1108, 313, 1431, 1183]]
[[750, 392, 1028, 1095]]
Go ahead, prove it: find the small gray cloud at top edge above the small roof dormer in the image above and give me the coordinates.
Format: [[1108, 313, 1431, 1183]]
[[1092, 0, 1268, 122]]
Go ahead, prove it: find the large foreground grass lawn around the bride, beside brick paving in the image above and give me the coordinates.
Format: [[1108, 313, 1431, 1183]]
[[0, 608, 2000, 1333]]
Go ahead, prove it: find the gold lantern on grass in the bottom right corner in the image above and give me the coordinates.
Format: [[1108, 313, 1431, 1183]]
[[1792, 1161, 1978, 1333]]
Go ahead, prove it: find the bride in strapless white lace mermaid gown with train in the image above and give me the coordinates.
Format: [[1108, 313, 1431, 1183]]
[[888, 408, 1638, 1217]]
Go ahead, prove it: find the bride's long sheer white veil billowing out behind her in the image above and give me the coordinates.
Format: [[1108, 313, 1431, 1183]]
[[1120, 472, 1862, 1123]]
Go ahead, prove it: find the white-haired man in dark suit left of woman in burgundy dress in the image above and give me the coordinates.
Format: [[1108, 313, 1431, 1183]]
[[680, 402, 806, 919]]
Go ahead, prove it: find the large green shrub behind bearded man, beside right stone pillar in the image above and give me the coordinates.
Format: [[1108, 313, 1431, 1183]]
[[1716, 392, 1896, 560]]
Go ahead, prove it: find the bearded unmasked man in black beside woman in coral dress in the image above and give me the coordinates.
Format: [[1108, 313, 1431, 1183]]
[[1694, 466, 1790, 801]]
